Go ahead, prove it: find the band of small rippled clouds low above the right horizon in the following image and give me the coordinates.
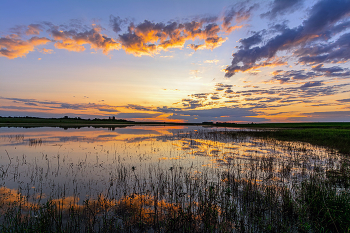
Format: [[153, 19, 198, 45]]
[[178, 80, 350, 115]]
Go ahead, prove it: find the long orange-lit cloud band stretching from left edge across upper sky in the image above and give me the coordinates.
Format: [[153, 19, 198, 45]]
[[0, 4, 256, 59]]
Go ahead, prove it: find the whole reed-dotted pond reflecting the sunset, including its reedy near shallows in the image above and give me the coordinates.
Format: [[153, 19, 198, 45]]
[[0, 125, 344, 232]]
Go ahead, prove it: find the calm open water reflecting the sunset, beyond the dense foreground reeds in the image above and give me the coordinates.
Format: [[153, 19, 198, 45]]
[[0, 126, 341, 206]]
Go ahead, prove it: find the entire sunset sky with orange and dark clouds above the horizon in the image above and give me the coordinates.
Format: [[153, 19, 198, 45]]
[[0, 0, 350, 123]]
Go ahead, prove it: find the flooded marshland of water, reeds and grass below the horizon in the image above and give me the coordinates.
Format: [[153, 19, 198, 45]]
[[0, 123, 350, 232]]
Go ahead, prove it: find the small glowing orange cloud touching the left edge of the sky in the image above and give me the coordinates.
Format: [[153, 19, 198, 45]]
[[0, 36, 51, 59]]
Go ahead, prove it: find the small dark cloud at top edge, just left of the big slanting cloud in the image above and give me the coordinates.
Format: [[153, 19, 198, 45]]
[[260, 0, 304, 20]]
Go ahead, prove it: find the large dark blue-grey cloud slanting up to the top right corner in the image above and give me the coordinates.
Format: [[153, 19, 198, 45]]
[[225, 0, 350, 77]]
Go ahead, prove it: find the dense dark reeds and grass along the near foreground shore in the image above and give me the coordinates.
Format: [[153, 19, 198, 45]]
[[0, 167, 350, 232]]
